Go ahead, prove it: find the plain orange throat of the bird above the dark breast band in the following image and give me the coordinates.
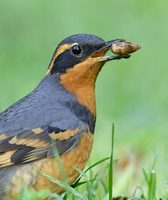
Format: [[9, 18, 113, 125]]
[[60, 60, 103, 116]]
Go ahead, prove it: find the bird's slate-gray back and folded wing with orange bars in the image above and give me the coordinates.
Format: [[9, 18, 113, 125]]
[[0, 74, 84, 168]]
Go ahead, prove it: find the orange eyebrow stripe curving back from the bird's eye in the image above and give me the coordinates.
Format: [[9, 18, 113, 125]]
[[47, 44, 72, 74]]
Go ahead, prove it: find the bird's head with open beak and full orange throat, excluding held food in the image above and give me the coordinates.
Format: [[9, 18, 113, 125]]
[[47, 34, 131, 115]]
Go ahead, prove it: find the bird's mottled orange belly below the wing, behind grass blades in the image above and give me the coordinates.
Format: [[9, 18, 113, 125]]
[[3, 133, 93, 200]]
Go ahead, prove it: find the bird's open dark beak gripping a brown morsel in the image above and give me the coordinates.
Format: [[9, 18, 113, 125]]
[[91, 39, 130, 62]]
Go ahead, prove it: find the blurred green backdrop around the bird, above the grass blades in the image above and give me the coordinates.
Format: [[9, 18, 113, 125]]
[[0, 0, 168, 197]]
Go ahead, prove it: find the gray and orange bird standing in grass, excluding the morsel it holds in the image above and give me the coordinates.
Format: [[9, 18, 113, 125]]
[[0, 33, 129, 200]]
